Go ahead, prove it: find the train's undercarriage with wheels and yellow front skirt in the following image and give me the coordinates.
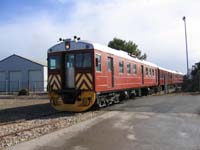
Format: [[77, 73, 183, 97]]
[[49, 85, 181, 112]]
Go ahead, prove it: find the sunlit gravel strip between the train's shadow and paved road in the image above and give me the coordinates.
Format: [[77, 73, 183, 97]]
[[0, 111, 104, 149]]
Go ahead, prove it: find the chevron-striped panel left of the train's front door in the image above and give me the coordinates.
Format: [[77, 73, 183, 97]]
[[49, 74, 61, 90]]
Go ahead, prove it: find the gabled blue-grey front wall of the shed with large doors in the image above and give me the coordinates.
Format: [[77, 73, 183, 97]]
[[0, 55, 47, 92]]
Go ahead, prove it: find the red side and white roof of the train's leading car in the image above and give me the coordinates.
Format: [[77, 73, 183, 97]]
[[94, 47, 157, 92]]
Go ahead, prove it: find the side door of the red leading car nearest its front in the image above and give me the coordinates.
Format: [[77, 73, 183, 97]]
[[107, 57, 114, 87]]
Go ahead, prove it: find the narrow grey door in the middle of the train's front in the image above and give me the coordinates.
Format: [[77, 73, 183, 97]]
[[65, 54, 75, 88]]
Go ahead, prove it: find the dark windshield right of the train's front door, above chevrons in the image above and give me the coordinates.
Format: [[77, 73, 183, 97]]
[[76, 53, 92, 68]]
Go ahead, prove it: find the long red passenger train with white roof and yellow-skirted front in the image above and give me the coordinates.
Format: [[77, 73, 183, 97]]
[[48, 39, 183, 112]]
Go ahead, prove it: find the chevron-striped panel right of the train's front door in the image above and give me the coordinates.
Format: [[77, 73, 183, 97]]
[[76, 73, 93, 90]]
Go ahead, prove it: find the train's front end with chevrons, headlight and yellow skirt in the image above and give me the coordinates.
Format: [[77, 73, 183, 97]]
[[48, 39, 96, 112]]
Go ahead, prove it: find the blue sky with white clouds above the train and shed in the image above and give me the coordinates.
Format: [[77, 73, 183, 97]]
[[0, 0, 200, 73]]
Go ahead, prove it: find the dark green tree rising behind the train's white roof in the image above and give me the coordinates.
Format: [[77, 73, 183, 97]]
[[108, 38, 147, 60]]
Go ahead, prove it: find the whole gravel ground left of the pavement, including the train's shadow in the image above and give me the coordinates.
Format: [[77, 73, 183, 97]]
[[0, 98, 104, 149]]
